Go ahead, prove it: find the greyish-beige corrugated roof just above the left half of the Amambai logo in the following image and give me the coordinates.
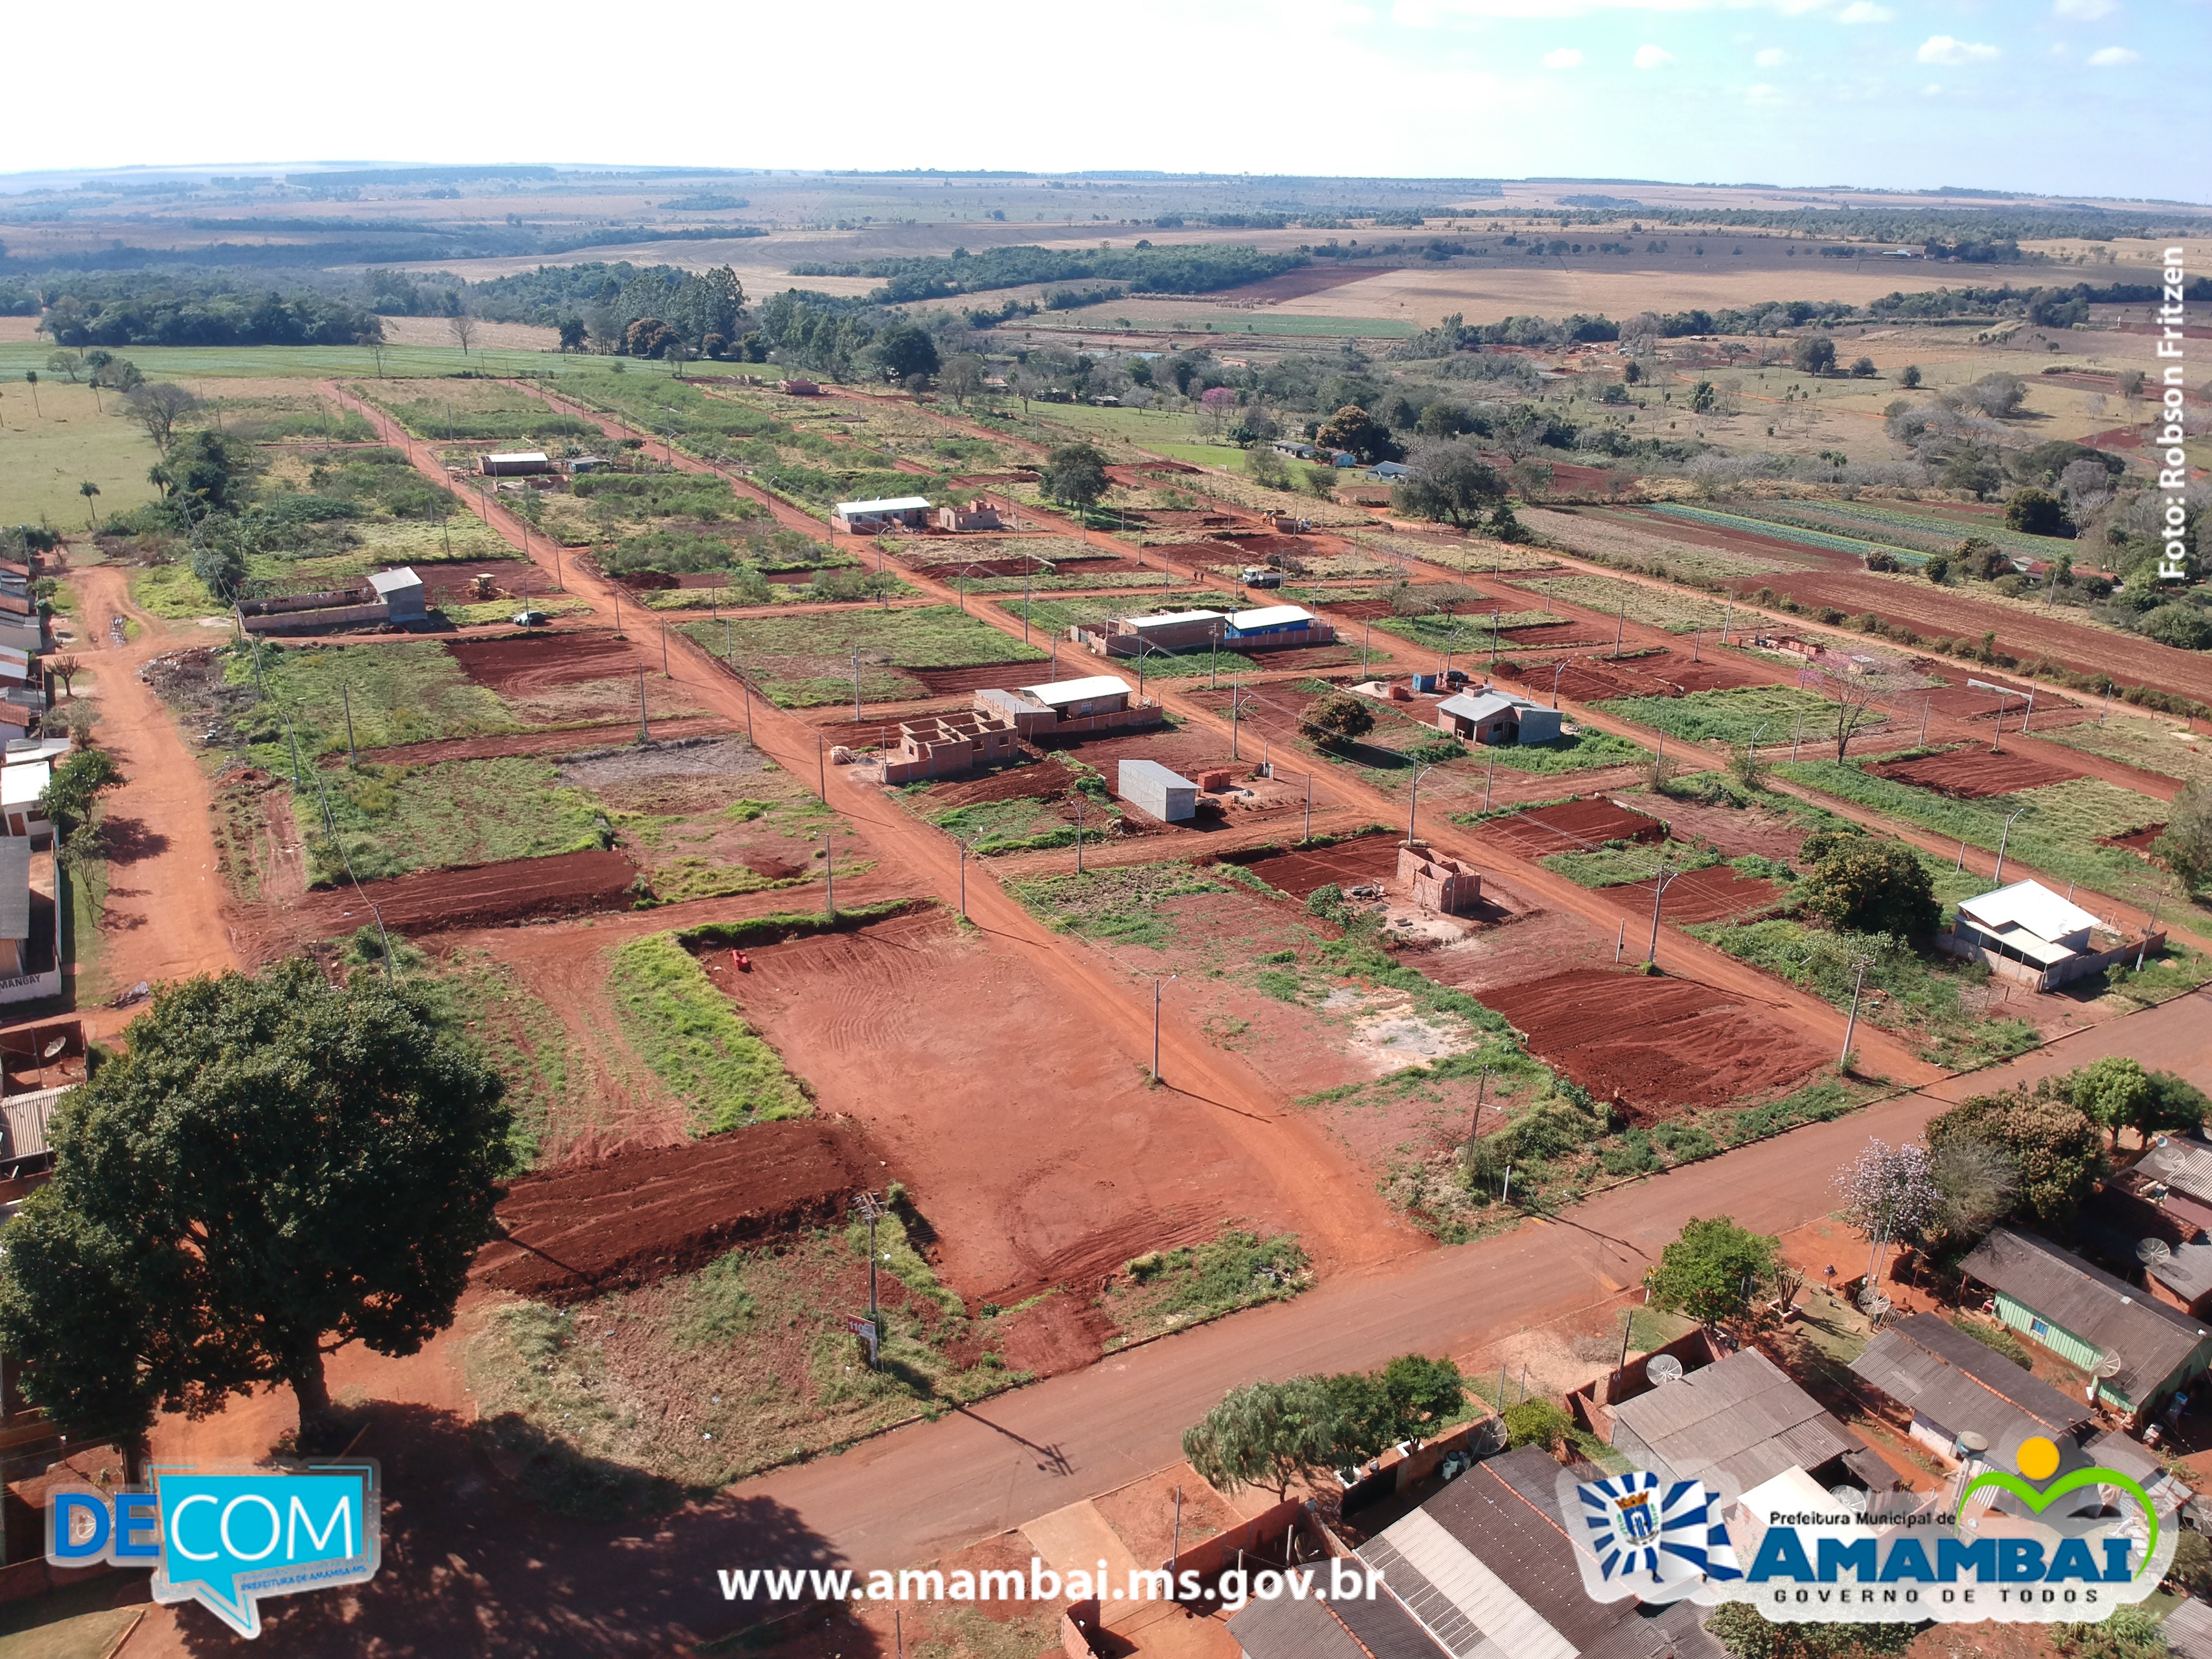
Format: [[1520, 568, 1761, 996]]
[[1613, 1347, 1862, 1491]]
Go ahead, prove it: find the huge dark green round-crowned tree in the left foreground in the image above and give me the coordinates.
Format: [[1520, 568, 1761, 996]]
[[0, 960, 509, 1449]]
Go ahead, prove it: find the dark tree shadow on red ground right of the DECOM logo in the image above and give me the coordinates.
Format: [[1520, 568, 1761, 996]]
[[177, 1403, 878, 1659]]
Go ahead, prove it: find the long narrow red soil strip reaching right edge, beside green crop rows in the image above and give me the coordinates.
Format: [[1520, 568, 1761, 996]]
[[1743, 571, 2212, 719]]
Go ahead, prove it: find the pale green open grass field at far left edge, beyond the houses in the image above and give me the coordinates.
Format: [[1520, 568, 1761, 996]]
[[0, 380, 157, 531]]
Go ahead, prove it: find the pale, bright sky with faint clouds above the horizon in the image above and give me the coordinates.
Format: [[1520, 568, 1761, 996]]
[[17, 0, 2212, 201]]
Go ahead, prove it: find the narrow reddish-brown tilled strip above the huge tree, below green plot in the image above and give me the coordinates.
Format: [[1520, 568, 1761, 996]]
[[239, 852, 637, 955]]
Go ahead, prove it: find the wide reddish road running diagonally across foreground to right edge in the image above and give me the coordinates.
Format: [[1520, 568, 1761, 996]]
[[739, 991, 2212, 1568]]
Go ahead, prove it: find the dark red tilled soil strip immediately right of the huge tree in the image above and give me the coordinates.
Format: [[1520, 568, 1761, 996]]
[[471, 1119, 871, 1303]]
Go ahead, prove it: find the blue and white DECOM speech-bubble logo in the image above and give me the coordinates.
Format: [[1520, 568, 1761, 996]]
[[46, 1458, 382, 1637]]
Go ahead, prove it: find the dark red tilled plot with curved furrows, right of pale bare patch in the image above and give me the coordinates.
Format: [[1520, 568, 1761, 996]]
[[1482, 969, 1827, 1122]]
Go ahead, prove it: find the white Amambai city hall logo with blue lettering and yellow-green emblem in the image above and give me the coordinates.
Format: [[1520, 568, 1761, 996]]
[[1559, 1435, 2175, 1624]]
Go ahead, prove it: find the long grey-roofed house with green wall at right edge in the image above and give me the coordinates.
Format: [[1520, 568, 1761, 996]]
[[1964, 1228, 2212, 1422]]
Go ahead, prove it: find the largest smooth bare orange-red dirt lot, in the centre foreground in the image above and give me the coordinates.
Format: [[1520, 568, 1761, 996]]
[[726, 911, 1318, 1305]]
